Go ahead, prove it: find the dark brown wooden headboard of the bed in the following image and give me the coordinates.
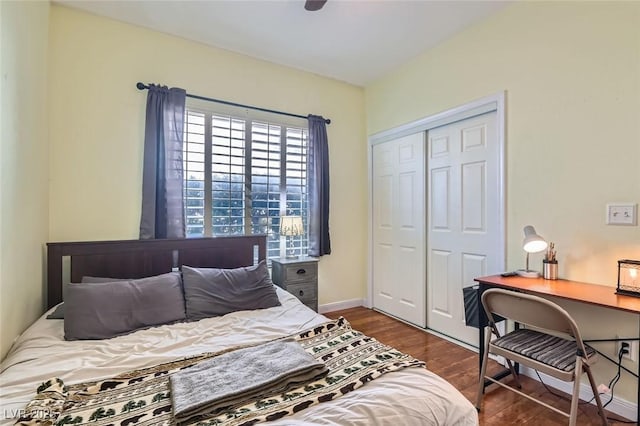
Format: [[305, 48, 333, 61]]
[[47, 235, 266, 308]]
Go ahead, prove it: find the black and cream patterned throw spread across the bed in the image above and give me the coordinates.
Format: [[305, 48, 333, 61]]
[[17, 318, 425, 426]]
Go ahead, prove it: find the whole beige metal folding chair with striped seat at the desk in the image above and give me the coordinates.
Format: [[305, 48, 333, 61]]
[[476, 288, 607, 426]]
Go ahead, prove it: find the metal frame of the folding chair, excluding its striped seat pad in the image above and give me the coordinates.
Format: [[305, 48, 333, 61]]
[[476, 288, 608, 426]]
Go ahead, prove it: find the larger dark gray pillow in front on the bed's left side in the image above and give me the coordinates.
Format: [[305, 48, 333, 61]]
[[64, 272, 186, 340]]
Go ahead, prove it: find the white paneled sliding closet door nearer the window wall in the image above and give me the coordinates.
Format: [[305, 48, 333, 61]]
[[372, 132, 426, 327]]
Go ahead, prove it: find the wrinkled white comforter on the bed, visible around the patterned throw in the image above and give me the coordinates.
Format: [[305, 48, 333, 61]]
[[0, 288, 478, 426]]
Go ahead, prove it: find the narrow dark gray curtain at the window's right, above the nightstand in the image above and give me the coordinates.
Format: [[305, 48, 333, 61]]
[[307, 115, 331, 256]]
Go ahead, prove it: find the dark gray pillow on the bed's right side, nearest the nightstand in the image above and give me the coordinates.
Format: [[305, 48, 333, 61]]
[[182, 260, 280, 320]]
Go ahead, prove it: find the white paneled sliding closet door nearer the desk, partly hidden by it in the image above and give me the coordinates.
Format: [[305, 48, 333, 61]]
[[427, 112, 504, 346]]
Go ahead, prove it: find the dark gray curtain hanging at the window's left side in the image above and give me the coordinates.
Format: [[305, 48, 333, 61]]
[[140, 84, 186, 239]]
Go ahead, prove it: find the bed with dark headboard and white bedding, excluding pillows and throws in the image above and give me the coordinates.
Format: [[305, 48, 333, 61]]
[[0, 236, 478, 425]]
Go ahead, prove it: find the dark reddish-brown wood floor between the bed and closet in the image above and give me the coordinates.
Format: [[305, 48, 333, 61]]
[[324, 308, 635, 426]]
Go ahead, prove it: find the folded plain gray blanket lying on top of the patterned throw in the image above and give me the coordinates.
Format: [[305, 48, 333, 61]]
[[169, 340, 329, 423]]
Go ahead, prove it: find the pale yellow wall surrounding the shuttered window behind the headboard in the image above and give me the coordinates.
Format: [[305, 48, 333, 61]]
[[49, 5, 367, 304]]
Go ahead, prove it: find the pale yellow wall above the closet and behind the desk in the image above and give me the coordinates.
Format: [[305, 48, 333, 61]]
[[365, 2, 640, 402]]
